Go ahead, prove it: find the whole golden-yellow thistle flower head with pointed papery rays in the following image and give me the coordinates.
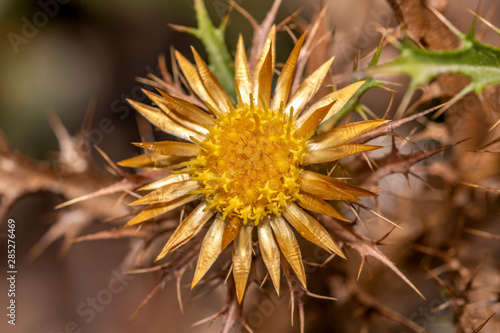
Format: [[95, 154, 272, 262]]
[[120, 28, 384, 302]]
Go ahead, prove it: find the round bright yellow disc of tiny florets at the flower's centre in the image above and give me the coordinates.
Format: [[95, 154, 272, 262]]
[[190, 104, 306, 224]]
